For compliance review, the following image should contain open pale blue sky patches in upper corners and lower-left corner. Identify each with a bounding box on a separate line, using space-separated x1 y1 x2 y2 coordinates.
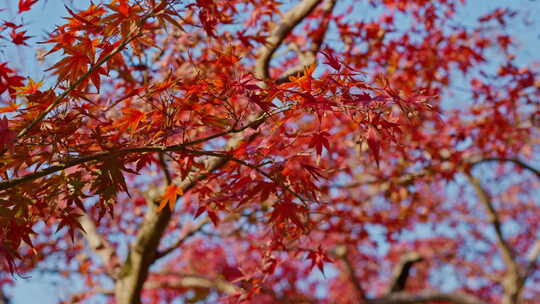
0 0 540 304
